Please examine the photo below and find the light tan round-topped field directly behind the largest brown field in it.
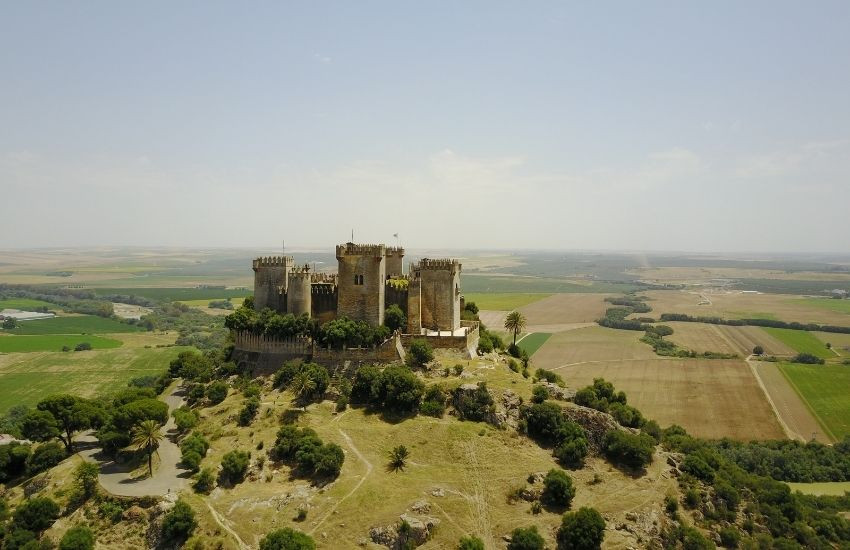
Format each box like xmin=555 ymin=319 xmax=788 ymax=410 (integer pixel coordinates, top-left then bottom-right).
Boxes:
xmin=533 ymin=326 xmax=657 ymax=369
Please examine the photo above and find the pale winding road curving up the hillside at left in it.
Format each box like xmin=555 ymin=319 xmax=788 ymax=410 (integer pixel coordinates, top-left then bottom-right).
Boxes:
xmin=76 ymin=384 xmax=191 ymax=497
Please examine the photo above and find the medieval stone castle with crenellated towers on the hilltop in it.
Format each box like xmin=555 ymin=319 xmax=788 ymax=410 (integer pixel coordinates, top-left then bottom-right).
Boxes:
xmin=253 ymin=242 xmax=470 ymax=337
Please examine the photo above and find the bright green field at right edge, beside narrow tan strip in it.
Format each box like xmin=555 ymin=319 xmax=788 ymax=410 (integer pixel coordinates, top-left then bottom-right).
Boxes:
xmin=779 ymin=363 xmax=850 ymax=440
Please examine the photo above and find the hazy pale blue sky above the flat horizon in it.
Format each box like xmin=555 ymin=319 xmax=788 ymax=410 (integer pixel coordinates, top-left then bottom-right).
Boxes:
xmin=0 ymin=0 xmax=850 ymax=252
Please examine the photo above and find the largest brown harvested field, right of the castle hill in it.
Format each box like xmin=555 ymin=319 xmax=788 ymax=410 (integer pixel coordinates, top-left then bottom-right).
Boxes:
xmin=539 ymin=360 xmax=785 ymax=440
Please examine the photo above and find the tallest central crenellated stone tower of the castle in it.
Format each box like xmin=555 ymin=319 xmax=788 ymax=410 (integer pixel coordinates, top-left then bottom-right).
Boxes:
xmin=336 ymin=243 xmax=387 ymax=326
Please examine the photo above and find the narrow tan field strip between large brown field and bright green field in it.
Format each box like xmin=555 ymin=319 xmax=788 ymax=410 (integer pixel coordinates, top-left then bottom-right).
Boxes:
xmin=750 ymin=361 xmax=832 ymax=443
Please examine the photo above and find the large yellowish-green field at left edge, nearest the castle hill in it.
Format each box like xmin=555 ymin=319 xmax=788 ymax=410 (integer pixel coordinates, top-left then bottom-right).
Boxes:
xmin=0 ymin=344 xmax=188 ymax=415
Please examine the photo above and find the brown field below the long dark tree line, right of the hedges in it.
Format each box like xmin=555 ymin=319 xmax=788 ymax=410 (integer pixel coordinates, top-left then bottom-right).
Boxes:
xmin=665 ymin=322 xmax=794 ymax=357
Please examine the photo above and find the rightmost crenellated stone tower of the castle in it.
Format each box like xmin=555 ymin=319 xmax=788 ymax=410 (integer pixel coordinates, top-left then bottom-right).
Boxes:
xmin=416 ymin=258 xmax=461 ymax=331
